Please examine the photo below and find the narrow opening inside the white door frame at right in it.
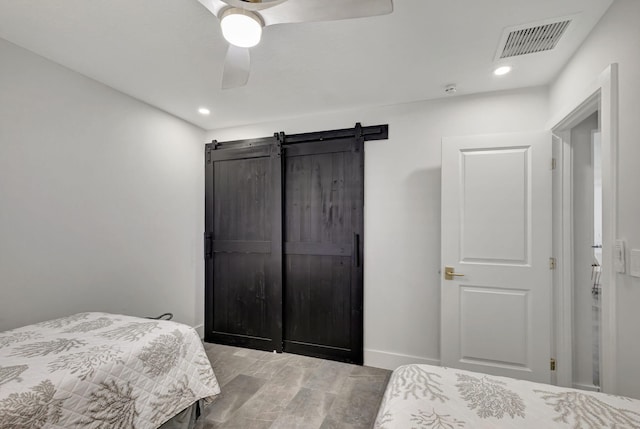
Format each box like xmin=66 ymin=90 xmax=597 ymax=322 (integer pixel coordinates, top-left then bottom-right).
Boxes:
xmin=556 ymin=110 xmax=603 ymax=391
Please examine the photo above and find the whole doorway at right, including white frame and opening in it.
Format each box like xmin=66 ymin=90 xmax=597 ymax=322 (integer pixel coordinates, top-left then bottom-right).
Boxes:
xmin=550 ymin=64 xmax=618 ymax=393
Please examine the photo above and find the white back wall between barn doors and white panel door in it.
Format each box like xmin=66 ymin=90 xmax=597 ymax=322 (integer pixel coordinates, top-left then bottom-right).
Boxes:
xmin=208 ymin=88 xmax=548 ymax=368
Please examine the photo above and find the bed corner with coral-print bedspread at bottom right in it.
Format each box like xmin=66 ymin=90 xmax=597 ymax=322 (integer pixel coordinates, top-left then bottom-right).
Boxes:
xmin=374 ymin=365 xmax=640 ymax=429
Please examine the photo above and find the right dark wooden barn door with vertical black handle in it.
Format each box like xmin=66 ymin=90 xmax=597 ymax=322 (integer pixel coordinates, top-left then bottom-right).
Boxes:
xmin=283 ymin=138 xmax=364 ymax=364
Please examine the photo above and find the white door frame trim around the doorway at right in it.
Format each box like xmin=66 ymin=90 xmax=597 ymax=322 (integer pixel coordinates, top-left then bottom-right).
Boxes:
xmin=548 ymin=64 xmax=618 ymax=393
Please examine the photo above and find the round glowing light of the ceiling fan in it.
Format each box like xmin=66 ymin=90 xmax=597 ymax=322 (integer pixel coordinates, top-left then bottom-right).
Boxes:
xmin=220 ymin=7 xmax=264 ymax=48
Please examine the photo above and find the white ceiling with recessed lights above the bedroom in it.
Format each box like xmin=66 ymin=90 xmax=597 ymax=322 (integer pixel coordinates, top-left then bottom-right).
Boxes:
xmin=0 ymin=0 xmax=612 ymax=129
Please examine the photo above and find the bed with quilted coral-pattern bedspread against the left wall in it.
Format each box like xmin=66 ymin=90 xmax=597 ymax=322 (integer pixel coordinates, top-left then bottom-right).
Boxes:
xmin=0 ymin=313 xmax=220 ymax=429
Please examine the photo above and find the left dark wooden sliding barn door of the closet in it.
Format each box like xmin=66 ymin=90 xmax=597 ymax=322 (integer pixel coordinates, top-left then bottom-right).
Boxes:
xmin=205 ymin=139 xmax=282 ymax=351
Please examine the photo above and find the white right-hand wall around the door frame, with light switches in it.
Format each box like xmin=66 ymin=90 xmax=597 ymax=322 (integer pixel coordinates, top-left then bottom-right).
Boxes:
xmin=550 ymin=0 xmax=640 ymax=398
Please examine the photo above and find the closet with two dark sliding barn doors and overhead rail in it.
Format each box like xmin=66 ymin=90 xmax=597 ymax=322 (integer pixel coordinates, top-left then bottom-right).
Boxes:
xmin=205 ymin=124 xmax=388 ymax=364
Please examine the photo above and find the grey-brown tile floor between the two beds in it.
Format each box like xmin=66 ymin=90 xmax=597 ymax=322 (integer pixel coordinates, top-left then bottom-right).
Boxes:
xmin=196 ymin=343 xmax=391 ymax=429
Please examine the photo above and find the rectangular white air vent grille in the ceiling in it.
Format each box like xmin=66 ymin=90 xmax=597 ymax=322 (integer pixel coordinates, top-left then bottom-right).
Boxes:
xmin=496 ymin=19 xmax=571 ymax=60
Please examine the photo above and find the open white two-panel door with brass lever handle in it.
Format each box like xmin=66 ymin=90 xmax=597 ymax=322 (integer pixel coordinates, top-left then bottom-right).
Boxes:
xmin=441 ymin=132 xmax=552 ymax=383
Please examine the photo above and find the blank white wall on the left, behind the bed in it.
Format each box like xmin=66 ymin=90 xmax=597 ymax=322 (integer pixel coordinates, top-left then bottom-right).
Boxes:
xmin=0 ymin=39 xmax=204 ymax=331
